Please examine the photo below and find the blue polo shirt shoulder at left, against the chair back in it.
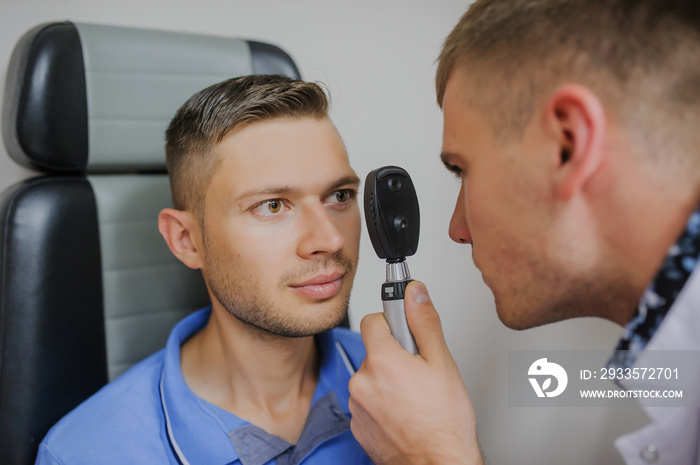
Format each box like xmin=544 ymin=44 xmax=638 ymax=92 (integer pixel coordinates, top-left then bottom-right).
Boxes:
xmin=37 ymin=351 xmax=170 ymax=464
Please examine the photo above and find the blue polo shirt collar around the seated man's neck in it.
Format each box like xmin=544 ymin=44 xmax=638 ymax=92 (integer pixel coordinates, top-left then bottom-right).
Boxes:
xmin=160 ymin=307 xmax=354 ymax=465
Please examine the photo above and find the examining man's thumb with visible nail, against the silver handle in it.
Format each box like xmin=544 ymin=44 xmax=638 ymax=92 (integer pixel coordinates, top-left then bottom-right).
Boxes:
xmin=405 ymin=281 xmax=449 ymax=360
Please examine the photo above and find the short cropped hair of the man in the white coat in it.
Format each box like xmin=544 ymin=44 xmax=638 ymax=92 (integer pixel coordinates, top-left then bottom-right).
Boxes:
xmin=436 ymin=0 xmax=700 ymax=158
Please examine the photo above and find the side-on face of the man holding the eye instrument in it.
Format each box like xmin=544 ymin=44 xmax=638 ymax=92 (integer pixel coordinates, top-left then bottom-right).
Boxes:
xmin=442 ymin=67 xmax=590 ymax=329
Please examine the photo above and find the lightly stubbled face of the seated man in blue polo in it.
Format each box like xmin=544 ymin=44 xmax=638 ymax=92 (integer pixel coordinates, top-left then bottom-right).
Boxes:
xmin=202 ymin=118 xmax=360 ymax=337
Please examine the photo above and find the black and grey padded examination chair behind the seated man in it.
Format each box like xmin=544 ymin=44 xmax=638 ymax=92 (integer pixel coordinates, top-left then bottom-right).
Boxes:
xmin=0 ymin=22 xmax=299 ymax=465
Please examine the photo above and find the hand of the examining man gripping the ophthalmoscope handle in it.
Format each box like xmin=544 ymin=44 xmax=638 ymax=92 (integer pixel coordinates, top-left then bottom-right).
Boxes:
xmin=349 ymin=281 xmax=483 ymax=465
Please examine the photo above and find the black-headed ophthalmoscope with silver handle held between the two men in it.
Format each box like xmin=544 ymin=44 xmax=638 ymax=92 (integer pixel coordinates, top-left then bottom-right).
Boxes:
xmin=364 ymin=166 xmax=420 ymax=354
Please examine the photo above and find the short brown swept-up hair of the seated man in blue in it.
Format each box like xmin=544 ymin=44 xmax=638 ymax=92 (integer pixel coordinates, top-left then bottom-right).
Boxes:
xmin=165 ymin=75 xmax=328 ymax=215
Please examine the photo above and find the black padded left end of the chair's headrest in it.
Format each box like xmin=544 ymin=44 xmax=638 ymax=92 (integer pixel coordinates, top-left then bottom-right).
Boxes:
xmin=3 ymin=22 xmax=88 ymax=172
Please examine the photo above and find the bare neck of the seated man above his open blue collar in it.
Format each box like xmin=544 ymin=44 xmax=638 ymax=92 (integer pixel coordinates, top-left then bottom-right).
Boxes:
xmin=181 ymin=306 xmax=318 ymax=444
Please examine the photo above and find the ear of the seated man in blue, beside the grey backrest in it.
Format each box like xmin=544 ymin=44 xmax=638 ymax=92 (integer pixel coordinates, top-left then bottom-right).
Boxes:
xmin=158 ymin=208 xmax=202 ymax=270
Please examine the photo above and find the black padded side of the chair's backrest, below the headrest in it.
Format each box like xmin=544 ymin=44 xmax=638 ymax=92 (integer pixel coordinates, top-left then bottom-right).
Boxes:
xmin=0 ymin=177 xmax=107 ymax=465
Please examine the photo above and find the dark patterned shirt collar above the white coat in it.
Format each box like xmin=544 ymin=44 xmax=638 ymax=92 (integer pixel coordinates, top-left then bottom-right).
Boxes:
xmin=608 ymin=208 xmax=700 ymax=368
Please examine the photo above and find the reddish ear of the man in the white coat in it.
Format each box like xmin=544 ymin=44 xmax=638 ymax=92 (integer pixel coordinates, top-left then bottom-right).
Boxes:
xmin=545 ymin=84 xmax=606 ymax=200
